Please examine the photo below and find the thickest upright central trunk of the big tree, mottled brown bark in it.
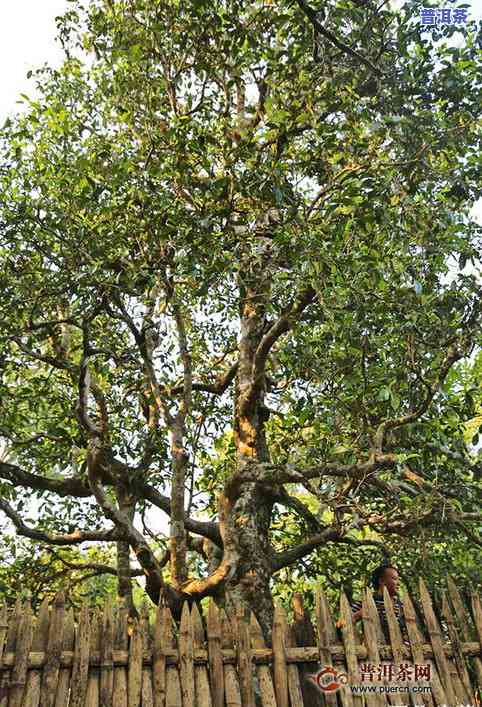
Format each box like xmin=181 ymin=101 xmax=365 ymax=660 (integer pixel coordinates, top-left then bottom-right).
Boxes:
xmin=226 ymin=253 xmax=274 ymax=642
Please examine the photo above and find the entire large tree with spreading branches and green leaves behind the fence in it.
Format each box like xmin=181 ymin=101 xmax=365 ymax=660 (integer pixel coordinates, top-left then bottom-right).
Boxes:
xmin=0 ymin=0 xmax=482 ymax=633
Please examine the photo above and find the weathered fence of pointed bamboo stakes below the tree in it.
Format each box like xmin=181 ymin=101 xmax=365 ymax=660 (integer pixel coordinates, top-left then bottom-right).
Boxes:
xmin=0 ymin=580 xmax=482 ymax=707
